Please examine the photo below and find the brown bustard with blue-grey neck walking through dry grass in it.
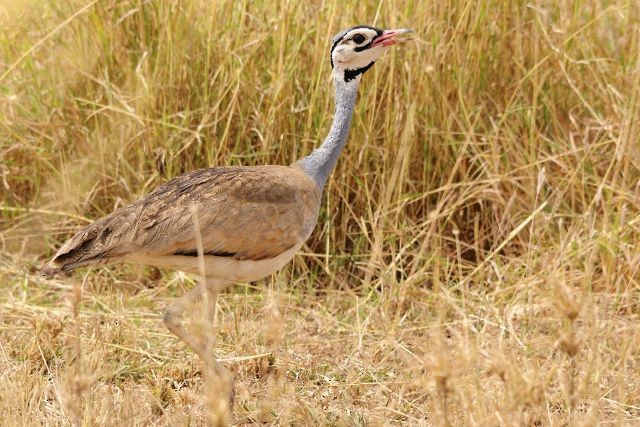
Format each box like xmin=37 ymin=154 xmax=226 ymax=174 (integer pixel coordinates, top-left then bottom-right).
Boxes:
xmin=39 ymin=25 xmax=412 ymax=412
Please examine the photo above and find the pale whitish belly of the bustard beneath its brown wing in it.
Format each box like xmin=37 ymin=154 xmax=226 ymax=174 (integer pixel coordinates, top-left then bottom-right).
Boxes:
xmin=131 ymin=242 xmax=304 ymax=284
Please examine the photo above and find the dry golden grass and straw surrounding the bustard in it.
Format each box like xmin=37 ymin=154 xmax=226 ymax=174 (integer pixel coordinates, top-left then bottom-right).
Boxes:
xmin=0 ymin=0 xmax=640 ymax=426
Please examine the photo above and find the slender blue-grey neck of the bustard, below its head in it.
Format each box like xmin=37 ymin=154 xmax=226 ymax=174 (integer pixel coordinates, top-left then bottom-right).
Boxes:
xmin=298 ymin=72 xmax=360 ymax=190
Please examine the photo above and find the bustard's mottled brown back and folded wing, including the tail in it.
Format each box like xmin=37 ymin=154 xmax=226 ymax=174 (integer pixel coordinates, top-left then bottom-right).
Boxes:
xmin=41 ymin=166 xmax=320 ymax=274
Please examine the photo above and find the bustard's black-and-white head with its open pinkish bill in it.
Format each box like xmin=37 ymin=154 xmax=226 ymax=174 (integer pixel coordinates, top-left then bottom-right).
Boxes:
xmin=331 ymin=25 xmax=412 ymax=83
